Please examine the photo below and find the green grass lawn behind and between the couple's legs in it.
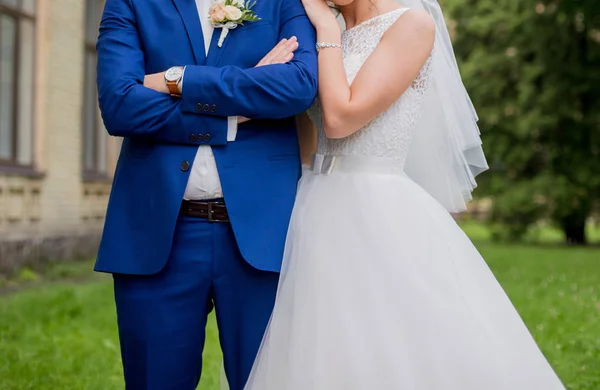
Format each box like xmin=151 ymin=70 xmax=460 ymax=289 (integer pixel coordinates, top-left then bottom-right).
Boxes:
xmin=0 ymin=233 xmax=600 ymax=390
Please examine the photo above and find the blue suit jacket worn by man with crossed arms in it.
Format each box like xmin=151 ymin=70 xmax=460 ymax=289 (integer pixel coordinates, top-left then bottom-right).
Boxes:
xmin=96 ymin=0 xmax=317 ymax=275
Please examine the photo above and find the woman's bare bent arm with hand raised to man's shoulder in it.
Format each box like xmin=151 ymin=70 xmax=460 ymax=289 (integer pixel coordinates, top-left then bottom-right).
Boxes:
xmin=304 ymin=0 xmax=435 ymax=138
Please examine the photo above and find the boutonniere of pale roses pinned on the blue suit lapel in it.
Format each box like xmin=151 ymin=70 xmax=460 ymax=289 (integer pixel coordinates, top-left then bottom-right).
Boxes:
xmin=208 ymin=0 xmax=260 ymax=47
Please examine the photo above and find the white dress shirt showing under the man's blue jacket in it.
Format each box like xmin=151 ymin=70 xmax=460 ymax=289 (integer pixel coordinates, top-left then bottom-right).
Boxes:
xmin=181 ymin=0 xmax=237 ymax=200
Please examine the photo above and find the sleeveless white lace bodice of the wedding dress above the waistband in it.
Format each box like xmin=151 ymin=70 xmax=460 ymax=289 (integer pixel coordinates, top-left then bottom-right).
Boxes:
xmin=308 ymin=8 xmax=431 ymax=166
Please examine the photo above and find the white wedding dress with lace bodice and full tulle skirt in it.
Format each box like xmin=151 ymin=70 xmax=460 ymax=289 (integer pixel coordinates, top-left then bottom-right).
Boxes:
xmin=246 ymin=9 xmax=564 ymax=390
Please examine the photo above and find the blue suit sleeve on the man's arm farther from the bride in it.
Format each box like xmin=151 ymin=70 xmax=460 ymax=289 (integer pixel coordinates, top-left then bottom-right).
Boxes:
xmin=97 ymin=0 xmax=227 ymax=145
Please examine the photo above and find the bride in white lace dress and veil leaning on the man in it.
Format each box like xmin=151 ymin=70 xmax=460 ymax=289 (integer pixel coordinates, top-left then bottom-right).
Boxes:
xmin=246 ymin=0 xmax=564 ymax=390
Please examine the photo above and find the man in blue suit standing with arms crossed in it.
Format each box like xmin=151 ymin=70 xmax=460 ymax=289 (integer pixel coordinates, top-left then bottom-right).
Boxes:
xmin=95 ymin=0 xmax=317 ymax=390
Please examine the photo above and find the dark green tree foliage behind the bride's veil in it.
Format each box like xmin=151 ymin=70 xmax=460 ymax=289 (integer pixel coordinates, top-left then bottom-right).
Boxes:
xmin=440 ymin=0 xmax=600 ymax=243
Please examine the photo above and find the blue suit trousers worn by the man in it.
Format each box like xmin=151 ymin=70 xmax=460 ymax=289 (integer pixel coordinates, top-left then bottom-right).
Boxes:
xmin=114 ymin=217 xmax=279 ymax=390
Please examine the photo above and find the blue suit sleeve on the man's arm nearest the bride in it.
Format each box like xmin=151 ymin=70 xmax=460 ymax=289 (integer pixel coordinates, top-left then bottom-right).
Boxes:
xmin=182 ymin=0 xmax=317 ymax=119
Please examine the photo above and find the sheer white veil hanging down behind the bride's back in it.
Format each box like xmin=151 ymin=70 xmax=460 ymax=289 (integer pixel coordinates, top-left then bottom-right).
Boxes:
xmin=398 ymin=0 xmax=488 ymax=212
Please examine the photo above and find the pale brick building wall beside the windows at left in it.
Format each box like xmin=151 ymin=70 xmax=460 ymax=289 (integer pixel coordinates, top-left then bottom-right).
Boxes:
xmin=0 ymin=0 xmax=119 ymax=273
